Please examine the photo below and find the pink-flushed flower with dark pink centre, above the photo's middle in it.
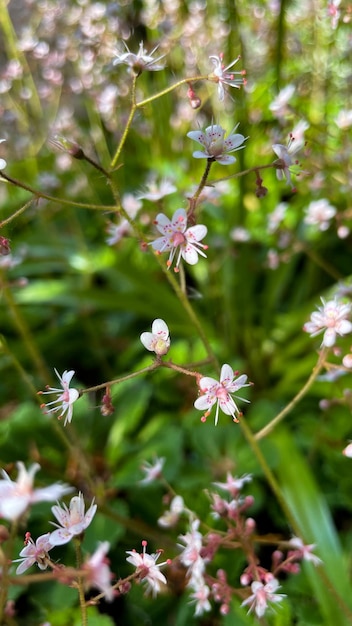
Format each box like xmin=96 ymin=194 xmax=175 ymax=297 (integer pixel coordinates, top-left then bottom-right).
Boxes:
xmin=150 ymin=209 xmax=208 ymax=272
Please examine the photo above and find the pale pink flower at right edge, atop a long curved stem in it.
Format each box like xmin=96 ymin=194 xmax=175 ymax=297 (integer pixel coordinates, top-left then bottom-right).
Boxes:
xmin=303 ymin=297 xmax=352 ymax=348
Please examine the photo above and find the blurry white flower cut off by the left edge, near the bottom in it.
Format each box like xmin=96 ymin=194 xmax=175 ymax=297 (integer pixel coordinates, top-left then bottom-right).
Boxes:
xmin=0 ymin=461 xmax=72 ymax=521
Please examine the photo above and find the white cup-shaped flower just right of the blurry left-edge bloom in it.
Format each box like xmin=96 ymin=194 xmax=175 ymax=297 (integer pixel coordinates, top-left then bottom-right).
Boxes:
xmin=50 ymin=493 xmax=97 ymax=546
